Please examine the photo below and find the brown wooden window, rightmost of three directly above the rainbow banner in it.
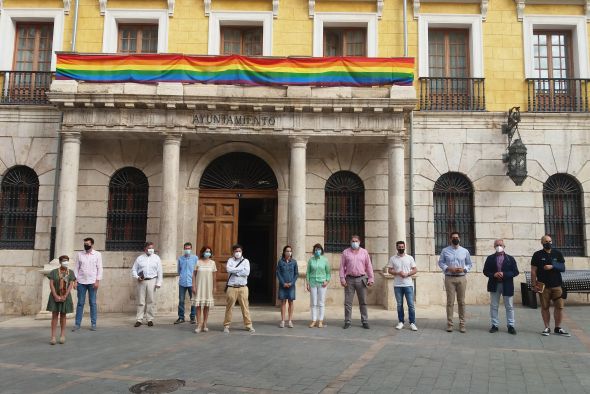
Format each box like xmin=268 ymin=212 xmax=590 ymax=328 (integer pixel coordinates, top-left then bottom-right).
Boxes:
xmin=324 ymin=27 xmax=367 ymax=56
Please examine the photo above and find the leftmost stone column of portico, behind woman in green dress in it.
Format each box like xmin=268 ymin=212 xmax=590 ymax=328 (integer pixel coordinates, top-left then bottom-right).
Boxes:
xmin=55 ymin=133 xmax=81 ymax=261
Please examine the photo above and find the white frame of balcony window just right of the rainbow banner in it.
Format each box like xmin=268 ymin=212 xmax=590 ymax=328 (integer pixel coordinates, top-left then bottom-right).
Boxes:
xmin=418 ymin=14 xmax=484 ymax=78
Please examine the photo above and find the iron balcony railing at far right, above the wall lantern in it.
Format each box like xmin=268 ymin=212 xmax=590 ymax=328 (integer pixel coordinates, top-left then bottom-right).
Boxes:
xmin=526 ymin=78 xmax=590 ymax=112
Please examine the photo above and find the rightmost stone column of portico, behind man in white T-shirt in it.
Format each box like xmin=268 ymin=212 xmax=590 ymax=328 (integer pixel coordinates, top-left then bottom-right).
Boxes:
xmin=387 ymin=136 xmax=408 ymax=256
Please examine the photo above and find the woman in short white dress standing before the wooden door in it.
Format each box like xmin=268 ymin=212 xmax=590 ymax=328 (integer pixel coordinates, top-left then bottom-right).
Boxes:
xmin=193 ymin=246 xmax=217 ymax=332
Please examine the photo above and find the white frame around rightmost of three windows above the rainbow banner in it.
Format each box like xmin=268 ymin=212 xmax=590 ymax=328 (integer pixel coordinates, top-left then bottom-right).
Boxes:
xmin=313 ymin=12 xmax=378 ymax=57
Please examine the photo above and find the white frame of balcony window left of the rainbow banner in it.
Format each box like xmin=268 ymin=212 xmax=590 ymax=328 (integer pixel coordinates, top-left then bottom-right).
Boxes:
xmin=0 ymin=8 xmax=64 ymax=71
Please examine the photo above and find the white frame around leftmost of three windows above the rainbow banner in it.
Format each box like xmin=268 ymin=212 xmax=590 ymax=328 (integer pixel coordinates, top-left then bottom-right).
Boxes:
xmin=102 ymin=8 xmax=168 ymax=53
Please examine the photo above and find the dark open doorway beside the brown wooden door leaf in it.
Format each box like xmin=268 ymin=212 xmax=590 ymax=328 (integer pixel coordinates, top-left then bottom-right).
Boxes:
xmin=238 ymin=198 xmax=276 ymax=304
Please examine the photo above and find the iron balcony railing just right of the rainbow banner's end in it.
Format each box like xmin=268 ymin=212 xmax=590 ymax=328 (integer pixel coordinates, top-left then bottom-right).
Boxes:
xmin=419 ymin=78 xmax=486 ymax=111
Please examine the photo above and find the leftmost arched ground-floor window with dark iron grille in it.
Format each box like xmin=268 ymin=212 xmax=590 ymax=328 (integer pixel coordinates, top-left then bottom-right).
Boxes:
xmin=0 ymin=166 xmax=39 ymax=249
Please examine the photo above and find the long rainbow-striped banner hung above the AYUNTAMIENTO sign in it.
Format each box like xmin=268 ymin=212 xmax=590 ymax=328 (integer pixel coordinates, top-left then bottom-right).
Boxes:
xmin=56 ymin=53 xmax=414 ymax=86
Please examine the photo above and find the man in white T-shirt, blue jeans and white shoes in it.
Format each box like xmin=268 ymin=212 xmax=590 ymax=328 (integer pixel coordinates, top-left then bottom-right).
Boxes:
xmin=387 ymin=241 xmax=418 ymax=331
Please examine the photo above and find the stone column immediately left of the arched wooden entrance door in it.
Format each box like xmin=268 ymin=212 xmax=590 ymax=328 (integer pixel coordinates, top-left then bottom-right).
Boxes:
xmin=158 ymin=134 xmax=182 ymax=273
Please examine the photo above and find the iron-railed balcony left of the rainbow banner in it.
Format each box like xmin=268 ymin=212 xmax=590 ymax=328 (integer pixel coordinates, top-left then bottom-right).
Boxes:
xmin=0 ymin=71 xmax=53 ymax=105
